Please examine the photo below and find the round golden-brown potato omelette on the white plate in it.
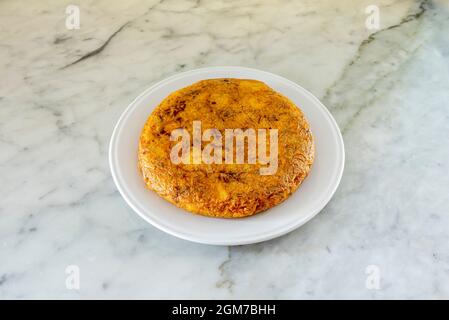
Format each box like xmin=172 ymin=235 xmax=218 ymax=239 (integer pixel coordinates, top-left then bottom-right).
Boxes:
xmin=138 ymin=78 xmax=314 ymax=218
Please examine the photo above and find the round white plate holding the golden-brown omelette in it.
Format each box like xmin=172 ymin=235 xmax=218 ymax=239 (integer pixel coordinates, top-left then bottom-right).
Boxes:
xmin=109 ymin=67 xmax=345 ymax=245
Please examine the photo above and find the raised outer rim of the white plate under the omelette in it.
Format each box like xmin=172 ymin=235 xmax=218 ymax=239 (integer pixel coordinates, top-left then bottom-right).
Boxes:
xmin=108 ymin=66 xmax=346 ymax=246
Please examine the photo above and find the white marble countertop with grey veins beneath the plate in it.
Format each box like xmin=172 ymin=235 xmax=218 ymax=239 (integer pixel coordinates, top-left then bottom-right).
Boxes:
xmin=0 ymin=0 xmax=449 ymax=299
